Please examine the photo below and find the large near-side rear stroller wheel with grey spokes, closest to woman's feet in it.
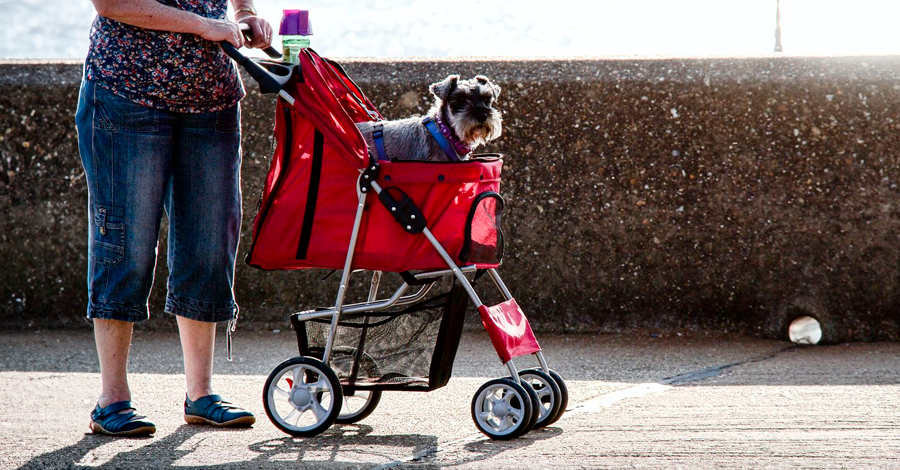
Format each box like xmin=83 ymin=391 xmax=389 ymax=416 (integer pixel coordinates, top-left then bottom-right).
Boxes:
xmin=263 ymin=357 xmax=343 ymax=437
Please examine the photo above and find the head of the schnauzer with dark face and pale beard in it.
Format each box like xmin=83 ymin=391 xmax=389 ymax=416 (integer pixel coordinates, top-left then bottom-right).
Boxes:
xmin=429 ymin=75 xmax=503 ymax=148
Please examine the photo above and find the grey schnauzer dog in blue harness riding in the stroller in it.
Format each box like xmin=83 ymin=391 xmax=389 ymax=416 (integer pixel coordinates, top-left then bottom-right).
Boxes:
xmin=356 ymin=75 xmax=503 ymax=161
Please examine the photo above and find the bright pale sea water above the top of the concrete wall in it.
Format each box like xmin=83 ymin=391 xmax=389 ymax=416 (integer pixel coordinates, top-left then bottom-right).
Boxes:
xmin=0 ymin=0 xmax=900 ymax=59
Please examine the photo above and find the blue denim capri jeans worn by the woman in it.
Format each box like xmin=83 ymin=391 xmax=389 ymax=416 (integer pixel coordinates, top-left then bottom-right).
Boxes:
xmin=75 ymin=80 xmax=241 ymax=322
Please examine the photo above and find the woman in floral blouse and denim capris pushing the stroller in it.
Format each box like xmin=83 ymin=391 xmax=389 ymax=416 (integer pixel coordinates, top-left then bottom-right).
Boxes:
xmin=75 ymin=0 xmax=272 ymax=436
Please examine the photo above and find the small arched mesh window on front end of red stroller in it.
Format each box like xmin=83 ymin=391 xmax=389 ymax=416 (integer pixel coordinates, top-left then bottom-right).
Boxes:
xmin=459 ymin=191 xmax=503 ymax=264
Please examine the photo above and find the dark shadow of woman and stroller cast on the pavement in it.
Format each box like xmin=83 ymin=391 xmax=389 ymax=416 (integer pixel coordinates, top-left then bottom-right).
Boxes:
xmin=20 ymin=425 xmax=562 ymax=470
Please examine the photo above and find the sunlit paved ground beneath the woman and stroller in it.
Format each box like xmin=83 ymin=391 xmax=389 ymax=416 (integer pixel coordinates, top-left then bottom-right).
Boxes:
xmin=0 ymin=331 xmax=900 ymax=469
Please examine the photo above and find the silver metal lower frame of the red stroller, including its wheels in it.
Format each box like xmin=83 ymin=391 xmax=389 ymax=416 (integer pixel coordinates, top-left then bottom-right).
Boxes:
xmin=263 ymin=169 xmax=568 ymax=440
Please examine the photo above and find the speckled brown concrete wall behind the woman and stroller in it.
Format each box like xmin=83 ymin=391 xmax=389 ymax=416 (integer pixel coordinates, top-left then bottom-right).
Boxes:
xmin=0 ymin=57 xmax=900 ymax=341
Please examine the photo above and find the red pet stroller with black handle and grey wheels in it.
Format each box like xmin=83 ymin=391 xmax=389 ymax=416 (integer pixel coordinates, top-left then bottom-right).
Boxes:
xmin=226 ymin=41 xmax=568 ymax=439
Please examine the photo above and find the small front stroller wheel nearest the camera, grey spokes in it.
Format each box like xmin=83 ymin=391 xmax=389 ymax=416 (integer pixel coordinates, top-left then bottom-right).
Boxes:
xmin=472 ymin=378 xmax=534 ymax=440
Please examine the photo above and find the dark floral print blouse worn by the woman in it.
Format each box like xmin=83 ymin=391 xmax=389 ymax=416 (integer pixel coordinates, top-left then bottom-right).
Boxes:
xmin=85 ymin=0 xmax=244 ymax=113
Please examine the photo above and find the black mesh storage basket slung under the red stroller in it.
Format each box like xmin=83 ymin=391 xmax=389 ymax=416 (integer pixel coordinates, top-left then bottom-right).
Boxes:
xmin=305 ymin=284 xmax=469 ymax=390
